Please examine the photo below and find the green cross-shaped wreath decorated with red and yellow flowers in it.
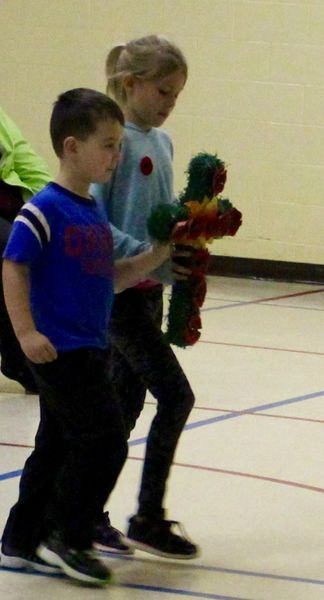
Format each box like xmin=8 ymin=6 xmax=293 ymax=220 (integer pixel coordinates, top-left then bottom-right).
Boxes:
xmin=148 ymin=152 xmax=242 ymax=348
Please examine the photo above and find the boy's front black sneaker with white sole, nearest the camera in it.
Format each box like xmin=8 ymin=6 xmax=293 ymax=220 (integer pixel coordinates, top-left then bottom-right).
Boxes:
xmin=37 ymin=535 xmax=112 ymax=585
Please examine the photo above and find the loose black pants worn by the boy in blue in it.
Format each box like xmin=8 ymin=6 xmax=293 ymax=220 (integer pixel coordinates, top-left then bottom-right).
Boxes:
xmin=2 ymin=348 xmax=127 ymax=552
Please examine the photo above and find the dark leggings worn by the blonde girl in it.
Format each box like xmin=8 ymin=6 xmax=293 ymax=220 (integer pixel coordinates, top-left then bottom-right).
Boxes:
xmin=109 ymin=285 xmax=194 ymax=518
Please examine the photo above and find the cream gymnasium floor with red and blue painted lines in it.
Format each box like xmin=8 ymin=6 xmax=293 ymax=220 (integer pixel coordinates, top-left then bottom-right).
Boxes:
xmin=0 ymin=278 xmax=324 ymax=600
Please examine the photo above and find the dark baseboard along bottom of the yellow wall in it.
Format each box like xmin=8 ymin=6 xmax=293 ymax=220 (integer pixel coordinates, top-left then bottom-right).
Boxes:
xmin=209 ymin=256 xmax=324 ymax=284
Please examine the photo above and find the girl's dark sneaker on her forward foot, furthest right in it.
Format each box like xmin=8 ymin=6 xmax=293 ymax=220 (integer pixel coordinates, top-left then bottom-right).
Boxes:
xmin=125 ymin=516 xmax=199 ymax=559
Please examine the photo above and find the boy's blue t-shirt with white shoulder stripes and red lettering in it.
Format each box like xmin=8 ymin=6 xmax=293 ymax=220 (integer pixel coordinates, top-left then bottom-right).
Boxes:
xmin=3 ymin=183 xmax=113 ymax=351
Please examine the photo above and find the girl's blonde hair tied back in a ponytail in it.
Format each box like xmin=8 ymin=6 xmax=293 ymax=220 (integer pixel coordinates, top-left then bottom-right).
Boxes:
xmin=106 ymin=35 xmax=188 ymax=104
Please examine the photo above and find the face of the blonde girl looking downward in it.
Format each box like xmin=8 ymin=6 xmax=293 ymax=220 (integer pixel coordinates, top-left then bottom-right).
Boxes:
xmin=123 ymin=70 xmax=186 ymax=129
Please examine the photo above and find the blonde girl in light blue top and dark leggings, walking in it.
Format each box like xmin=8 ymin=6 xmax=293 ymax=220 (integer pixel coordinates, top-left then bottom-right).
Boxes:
xmin=92 ymin=35 xmax=198 ymax=559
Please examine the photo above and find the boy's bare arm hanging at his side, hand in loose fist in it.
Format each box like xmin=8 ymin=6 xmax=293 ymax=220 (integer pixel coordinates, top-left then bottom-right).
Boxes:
xmin=2 ymin=259 xmax=57 ymax=363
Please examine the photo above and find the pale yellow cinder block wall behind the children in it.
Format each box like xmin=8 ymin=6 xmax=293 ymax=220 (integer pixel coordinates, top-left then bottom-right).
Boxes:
xmin=0 ymin=0 xmax=324 ymax=264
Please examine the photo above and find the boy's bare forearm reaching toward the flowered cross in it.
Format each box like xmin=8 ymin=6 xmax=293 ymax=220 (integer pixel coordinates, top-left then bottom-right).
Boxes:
xmin=114 ymin=243 xmax=171 ymax=293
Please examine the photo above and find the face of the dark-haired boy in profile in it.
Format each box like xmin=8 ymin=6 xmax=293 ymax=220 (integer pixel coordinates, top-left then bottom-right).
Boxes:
xmin=77 ymin=118 xmax=124 ymax=183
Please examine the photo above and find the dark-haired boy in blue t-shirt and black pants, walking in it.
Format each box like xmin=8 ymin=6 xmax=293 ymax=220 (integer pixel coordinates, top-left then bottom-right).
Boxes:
xmin=1 ymin=88 xmax=170 ymax=585
